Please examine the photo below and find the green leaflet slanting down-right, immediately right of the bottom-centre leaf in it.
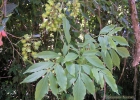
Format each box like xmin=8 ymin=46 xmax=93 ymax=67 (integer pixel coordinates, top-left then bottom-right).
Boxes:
xmin=81 ymin=73 xmax=95 ymax=95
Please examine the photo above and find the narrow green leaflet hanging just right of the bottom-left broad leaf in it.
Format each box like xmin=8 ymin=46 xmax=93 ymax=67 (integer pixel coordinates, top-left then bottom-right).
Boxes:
xmin=49 ymin=73 xmax=58 ymax=96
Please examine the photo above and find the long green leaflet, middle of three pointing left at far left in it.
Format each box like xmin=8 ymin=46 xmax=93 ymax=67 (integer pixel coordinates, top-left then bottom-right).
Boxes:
xmin=24 ymin=61 xmax=54 ymax=74
